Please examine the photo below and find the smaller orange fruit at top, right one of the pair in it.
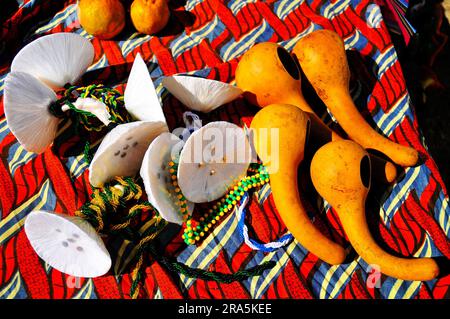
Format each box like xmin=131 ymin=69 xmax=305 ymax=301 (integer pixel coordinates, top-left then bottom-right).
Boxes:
xmin=130 ymin=0 xmax=170 ymax=34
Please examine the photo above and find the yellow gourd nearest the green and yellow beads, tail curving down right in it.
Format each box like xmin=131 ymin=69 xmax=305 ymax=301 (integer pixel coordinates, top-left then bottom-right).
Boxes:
xmin=251 ymin=104 xmax=346 ymax=265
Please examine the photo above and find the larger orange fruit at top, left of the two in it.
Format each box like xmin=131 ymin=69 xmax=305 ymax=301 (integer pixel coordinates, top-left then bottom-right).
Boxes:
xmin=78 ymin=0 xmax=125 ymax=39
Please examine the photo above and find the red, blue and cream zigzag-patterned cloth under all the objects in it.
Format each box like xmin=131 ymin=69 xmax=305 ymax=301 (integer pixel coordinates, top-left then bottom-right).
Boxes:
xmin=0 ymin=0 xmax=450 ymax=298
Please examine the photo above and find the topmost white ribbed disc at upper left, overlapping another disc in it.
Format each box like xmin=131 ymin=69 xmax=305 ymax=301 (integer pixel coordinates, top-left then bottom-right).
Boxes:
xmin=11 ymin=32 xmax=94 ymax=89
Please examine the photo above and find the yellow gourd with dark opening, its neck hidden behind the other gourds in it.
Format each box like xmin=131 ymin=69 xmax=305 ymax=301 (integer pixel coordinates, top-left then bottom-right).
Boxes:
xmin=236 ymin=42 xmax=397 ymax=183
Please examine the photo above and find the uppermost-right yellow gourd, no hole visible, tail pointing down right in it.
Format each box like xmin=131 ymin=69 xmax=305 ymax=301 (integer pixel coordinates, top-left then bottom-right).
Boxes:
xmin=293 ymin=30 xmax=419 ymax=166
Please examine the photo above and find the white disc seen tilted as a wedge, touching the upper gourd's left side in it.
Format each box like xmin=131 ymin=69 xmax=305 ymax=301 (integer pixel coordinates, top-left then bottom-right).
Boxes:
xmin=162 ymin=75 xmax=243 ymax=113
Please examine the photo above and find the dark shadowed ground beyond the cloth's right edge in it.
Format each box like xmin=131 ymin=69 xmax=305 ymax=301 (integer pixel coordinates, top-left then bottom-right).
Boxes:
xmin=398 ymin=0 xmax=450 ymax=188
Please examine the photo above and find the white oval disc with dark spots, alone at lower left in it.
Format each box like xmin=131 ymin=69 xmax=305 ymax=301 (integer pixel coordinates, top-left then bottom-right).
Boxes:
xmin=24 ymin=211 xmax=111 ymax=278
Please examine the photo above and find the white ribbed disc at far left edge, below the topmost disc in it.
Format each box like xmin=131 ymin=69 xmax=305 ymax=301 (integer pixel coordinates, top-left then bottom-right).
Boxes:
xmin=4 ymin=72 xmax=60 ymax=153
